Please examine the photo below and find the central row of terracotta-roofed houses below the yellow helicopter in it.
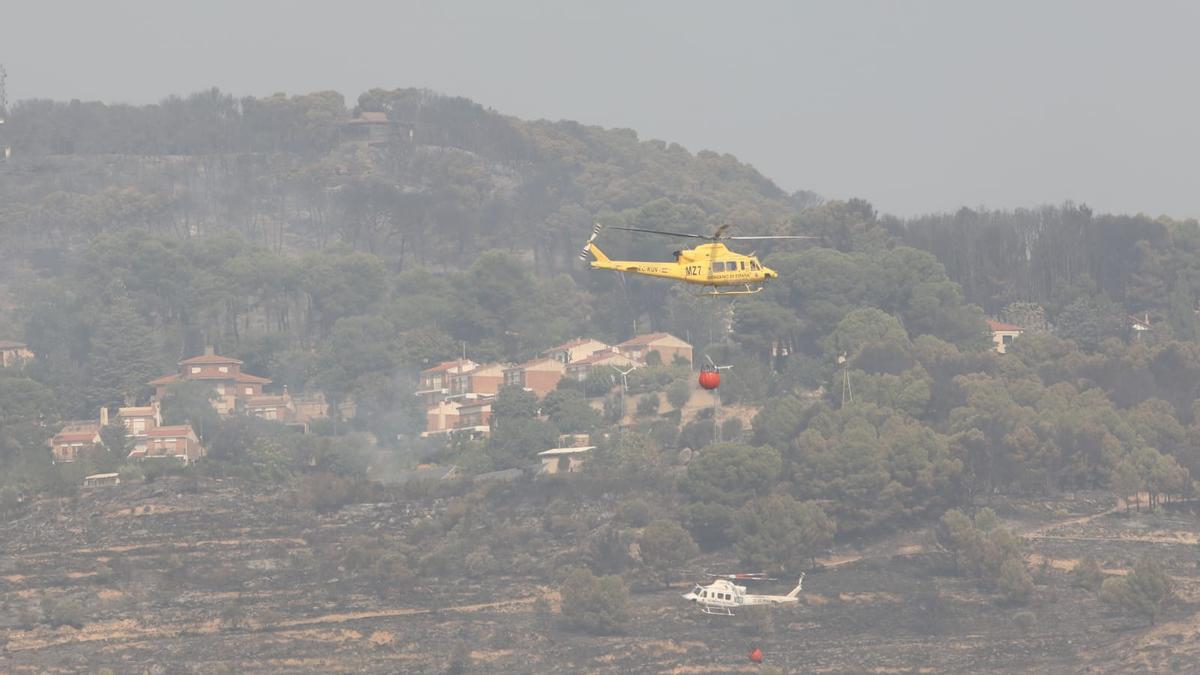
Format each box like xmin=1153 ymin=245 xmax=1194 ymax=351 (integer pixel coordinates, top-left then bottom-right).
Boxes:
xmin=416 ymin=333 xmax=692 ymax=437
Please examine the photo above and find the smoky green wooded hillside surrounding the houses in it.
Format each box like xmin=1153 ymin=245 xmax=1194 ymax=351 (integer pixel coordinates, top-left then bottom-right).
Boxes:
xmin=0 ymin=89 xmax=1200 ymax=544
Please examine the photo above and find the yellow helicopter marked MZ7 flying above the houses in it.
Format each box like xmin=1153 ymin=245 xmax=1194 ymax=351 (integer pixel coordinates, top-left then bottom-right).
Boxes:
xmin=580 ymin=223 xmax=815 ymax=295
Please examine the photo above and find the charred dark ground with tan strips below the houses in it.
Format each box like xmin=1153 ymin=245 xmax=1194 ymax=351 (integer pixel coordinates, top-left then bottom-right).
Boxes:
xmin=0 ymin=479 xmax=1200 ymax=673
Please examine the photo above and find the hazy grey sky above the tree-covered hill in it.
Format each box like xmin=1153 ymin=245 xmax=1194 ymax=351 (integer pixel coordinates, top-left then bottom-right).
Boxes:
xmin=9 ymin=0 xmax=1200 ymax=216
